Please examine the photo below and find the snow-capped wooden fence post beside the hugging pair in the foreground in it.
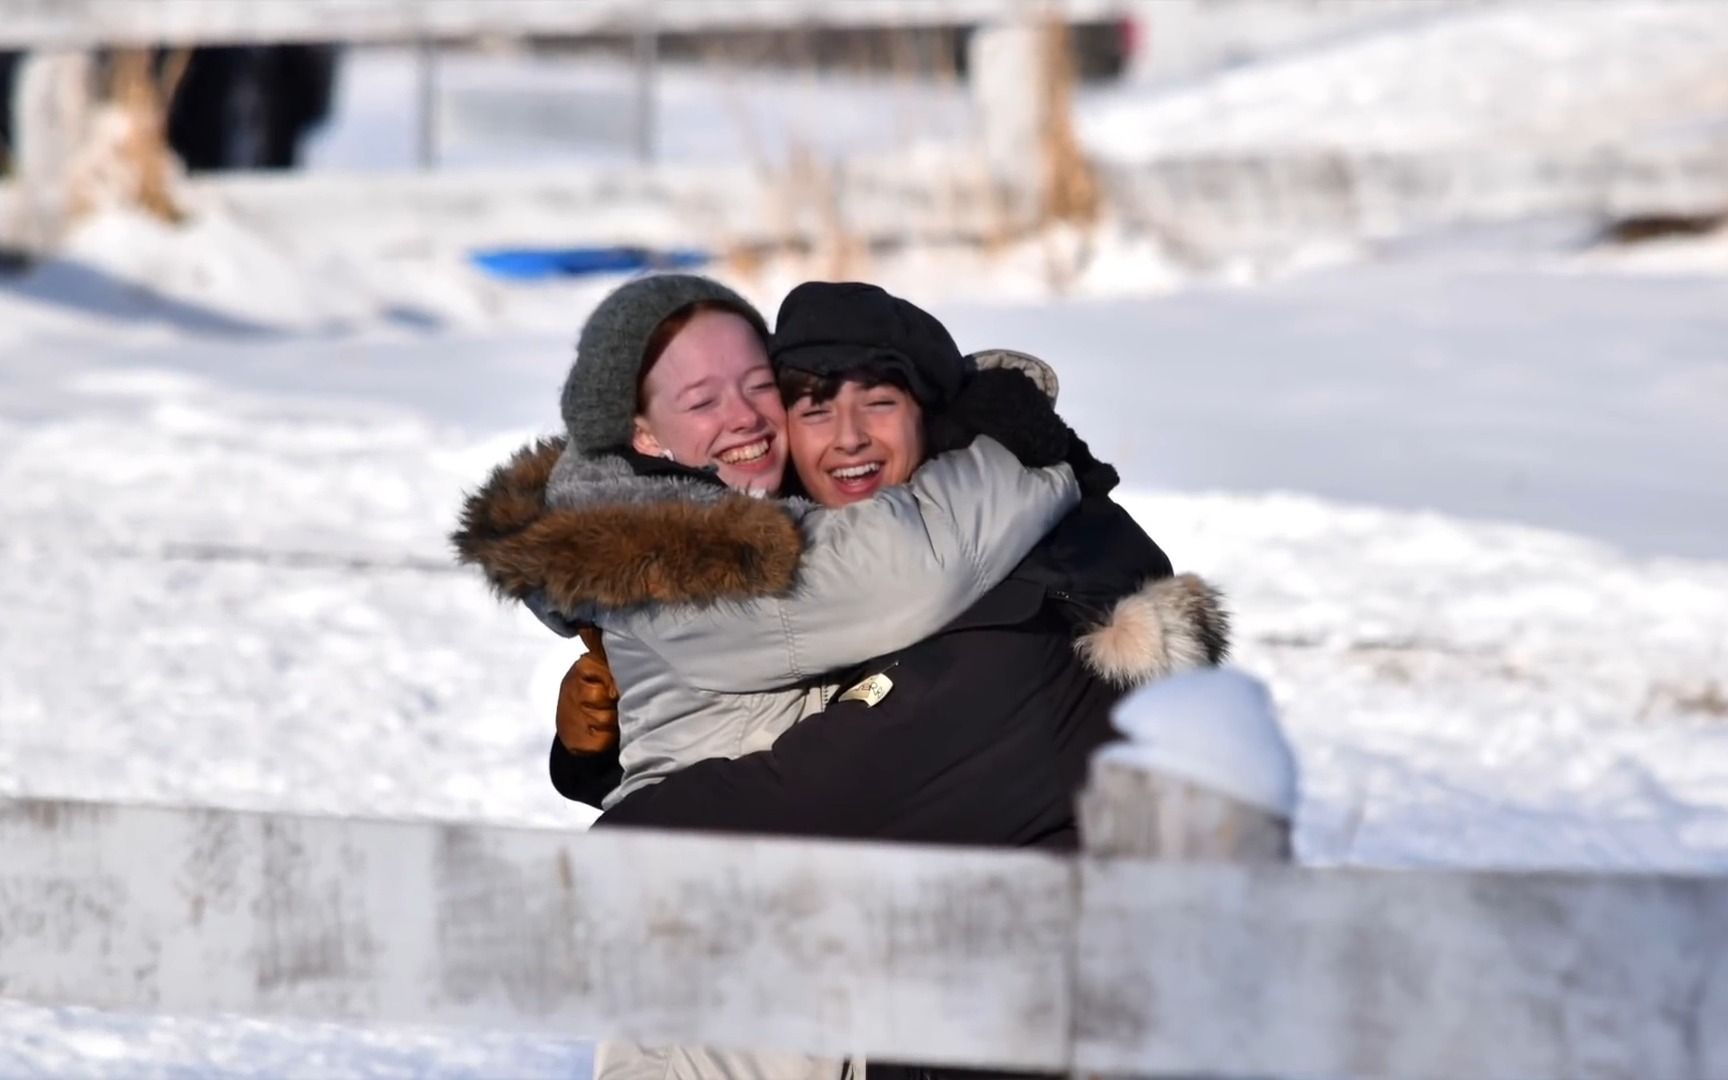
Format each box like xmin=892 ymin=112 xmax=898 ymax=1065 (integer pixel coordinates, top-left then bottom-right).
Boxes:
xmin=1075 ymin=669 xmax=1296 ymax=1080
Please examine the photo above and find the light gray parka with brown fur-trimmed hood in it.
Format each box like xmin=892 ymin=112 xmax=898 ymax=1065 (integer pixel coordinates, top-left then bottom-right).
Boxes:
xmin=454 ymin=437 xmax=1078 ymax=807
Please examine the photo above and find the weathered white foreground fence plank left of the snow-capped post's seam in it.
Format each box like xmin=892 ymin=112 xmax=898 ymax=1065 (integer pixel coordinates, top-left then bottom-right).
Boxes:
xmin=0 ymin=800 xmax=1075 ymax=1068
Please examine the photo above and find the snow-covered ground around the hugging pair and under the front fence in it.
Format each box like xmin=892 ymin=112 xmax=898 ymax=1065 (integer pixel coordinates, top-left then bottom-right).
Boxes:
xmin=0 ymin=5 xmax=1728 ymax=1077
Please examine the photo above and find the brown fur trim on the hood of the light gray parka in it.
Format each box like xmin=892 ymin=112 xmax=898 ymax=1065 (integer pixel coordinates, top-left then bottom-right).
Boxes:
xmin=451 ymin=437 xmax=804 ymax=613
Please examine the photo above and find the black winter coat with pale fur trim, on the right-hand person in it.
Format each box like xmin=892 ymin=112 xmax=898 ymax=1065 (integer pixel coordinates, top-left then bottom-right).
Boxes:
xmin=551 ymin=498 xmax=1225 ymax=848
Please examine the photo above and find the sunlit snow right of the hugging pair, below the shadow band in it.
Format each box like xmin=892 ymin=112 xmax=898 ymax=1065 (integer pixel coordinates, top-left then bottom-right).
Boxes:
xmin=1123 ymin=494 xmax=1728 ymax=873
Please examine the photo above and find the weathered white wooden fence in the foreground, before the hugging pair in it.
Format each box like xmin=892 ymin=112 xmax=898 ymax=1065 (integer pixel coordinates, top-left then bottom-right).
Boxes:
xmin=0 ymin=670 xmax=1728 ymax=1080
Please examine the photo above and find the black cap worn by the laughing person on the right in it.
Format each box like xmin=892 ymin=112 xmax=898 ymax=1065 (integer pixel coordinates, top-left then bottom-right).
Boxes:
xmin=769 ymin=282 xmax=973 ymax=411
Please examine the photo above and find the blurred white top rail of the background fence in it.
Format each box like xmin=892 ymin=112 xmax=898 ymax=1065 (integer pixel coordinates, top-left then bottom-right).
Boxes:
xmin=0 ymin=0 xmax=1125 ymax=48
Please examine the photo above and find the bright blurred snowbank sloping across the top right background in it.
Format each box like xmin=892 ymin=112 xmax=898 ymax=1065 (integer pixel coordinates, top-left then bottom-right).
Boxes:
xmin=1080 ymin=0 xmax=1728 ymax=159
